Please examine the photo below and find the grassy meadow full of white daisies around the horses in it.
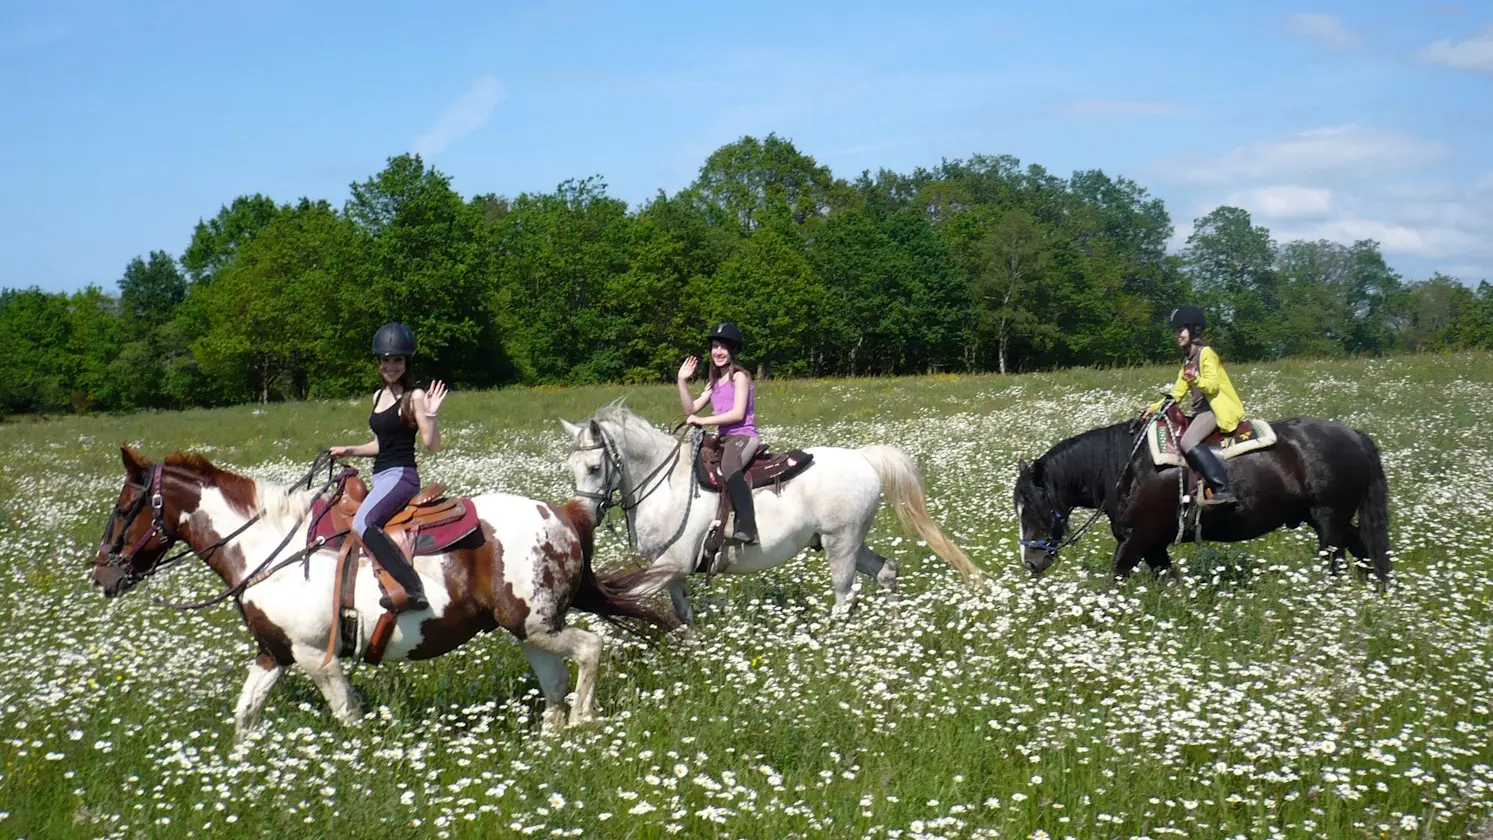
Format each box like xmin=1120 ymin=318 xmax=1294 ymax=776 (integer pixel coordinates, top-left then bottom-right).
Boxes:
xmin=0 ymin=354 xmax=1493 ymax=840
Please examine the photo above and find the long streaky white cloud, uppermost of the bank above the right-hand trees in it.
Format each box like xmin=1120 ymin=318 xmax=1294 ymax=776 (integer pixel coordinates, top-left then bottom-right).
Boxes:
xmin=1157 ymin=125 xmax=1448 ymax=185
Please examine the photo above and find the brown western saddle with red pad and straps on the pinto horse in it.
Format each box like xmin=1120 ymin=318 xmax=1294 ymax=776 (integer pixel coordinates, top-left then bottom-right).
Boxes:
xmin=306 ymin=467 xmax=484 ymax=665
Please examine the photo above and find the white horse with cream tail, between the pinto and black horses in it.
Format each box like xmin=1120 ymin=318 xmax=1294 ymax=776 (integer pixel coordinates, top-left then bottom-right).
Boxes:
xmin=560 ymin=403 xmax=981 ymax=627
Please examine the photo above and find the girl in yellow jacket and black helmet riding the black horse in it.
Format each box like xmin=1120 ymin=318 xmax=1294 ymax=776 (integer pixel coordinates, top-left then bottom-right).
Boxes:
xmin=1141 ymin=306 xmax=1244 ymax=506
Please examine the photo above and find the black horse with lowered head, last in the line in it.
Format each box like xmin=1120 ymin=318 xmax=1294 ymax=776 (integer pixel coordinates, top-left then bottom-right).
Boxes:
xmin=1012 ymin=418 xmax=1390 ymax=586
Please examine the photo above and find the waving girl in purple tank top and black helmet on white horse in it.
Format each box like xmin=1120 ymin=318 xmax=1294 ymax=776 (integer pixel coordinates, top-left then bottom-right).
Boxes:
xmin=679 ymin=324 xmax=760 ymax=545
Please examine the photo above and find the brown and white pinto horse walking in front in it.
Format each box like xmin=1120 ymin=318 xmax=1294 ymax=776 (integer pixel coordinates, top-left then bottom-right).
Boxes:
xmin=93 ymin=448 xmax=672 ymax=737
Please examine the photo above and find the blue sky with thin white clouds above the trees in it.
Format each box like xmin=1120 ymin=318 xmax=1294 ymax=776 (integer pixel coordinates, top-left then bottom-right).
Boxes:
xmin=0 ymin=0 xmax=1493 ymax=291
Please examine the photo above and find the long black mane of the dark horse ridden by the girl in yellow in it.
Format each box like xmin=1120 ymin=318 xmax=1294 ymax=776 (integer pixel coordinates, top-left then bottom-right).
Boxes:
xmin=1014 ymin=421 xmax=1135 ymax=510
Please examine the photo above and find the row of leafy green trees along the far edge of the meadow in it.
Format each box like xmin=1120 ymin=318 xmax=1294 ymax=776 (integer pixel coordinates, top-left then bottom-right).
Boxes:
xmin=0 ymin=136 xmax=1493 ymax=413
